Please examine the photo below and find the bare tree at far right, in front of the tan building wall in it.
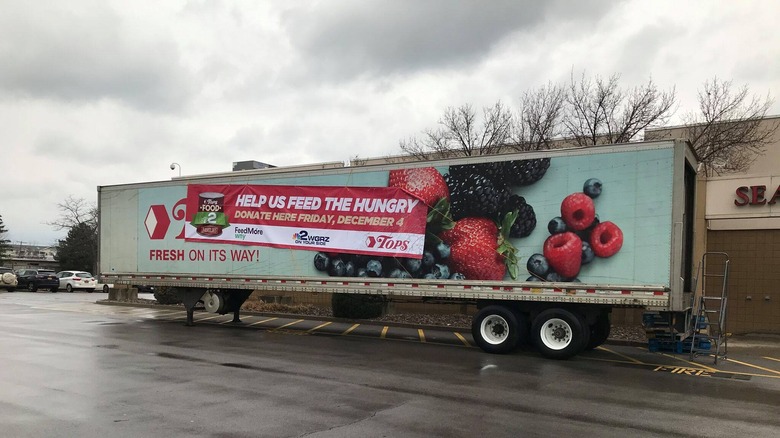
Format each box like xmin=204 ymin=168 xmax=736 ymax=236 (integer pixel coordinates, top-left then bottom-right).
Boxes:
xmin=684 ymin=77 xmax=780 ymax=176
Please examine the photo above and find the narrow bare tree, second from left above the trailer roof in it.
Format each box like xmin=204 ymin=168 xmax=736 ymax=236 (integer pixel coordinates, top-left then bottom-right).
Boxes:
xmin=511 ymin=83 xmax=566 ymax=151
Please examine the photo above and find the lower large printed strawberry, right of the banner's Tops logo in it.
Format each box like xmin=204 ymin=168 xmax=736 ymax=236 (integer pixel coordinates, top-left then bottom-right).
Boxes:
xmin=440 ymin=214 xmax=517 ymax=280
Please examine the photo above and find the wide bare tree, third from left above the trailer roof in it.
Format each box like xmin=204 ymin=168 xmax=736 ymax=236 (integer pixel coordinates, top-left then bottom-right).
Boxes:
xmin=563 ymin=73 xmax=676 ymax=146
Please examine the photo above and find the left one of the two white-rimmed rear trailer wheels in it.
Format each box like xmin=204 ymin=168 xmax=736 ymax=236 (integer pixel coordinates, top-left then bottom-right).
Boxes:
xmin=471 ymin=305 xmax=527 ymax=354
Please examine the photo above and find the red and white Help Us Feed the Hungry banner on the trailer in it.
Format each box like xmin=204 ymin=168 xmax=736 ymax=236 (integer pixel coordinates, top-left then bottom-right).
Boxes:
xmin=184 ymin=185 xmax=428 ymax=258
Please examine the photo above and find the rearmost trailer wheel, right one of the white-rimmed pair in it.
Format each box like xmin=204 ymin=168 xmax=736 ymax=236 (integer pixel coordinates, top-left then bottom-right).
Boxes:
xmin=531 ymin=309 xmax=590 ymax=359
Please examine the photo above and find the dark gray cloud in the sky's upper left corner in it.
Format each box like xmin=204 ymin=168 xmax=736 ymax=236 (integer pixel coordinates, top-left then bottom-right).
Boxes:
xmin=0 ymin=2 xmax=190 ymax=111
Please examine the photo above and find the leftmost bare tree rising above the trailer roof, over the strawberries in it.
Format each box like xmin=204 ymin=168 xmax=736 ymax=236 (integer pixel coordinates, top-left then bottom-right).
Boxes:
xmin=399 ymin=101 xmax=512 ymax=160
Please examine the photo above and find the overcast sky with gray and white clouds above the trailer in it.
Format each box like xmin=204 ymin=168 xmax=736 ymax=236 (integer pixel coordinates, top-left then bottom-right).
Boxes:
xmin=0 ymin=0 xmax=780 ymax=245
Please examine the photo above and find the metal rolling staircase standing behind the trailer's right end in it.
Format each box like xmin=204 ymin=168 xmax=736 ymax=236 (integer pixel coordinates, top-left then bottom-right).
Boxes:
xmin=690 ymin=252 xmax=729 ymax=365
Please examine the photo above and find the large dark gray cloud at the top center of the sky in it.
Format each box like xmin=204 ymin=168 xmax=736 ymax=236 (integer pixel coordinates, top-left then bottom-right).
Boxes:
xmin=283 ymin=0 xmax=614 ymax=79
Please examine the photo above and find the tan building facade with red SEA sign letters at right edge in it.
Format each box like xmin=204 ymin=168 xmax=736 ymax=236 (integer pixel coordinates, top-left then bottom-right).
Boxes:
xmin=645 ymin=116 xmax=780 ymax=333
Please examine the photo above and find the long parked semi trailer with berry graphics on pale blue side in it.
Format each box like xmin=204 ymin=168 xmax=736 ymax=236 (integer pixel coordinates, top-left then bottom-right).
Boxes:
xmin=98 ymin=140 xmax=697 ymax=359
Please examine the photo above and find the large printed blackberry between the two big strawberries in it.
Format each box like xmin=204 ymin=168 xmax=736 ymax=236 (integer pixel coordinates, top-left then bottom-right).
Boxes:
xmin=444 ymin=173 xmax=509 ymax=220
